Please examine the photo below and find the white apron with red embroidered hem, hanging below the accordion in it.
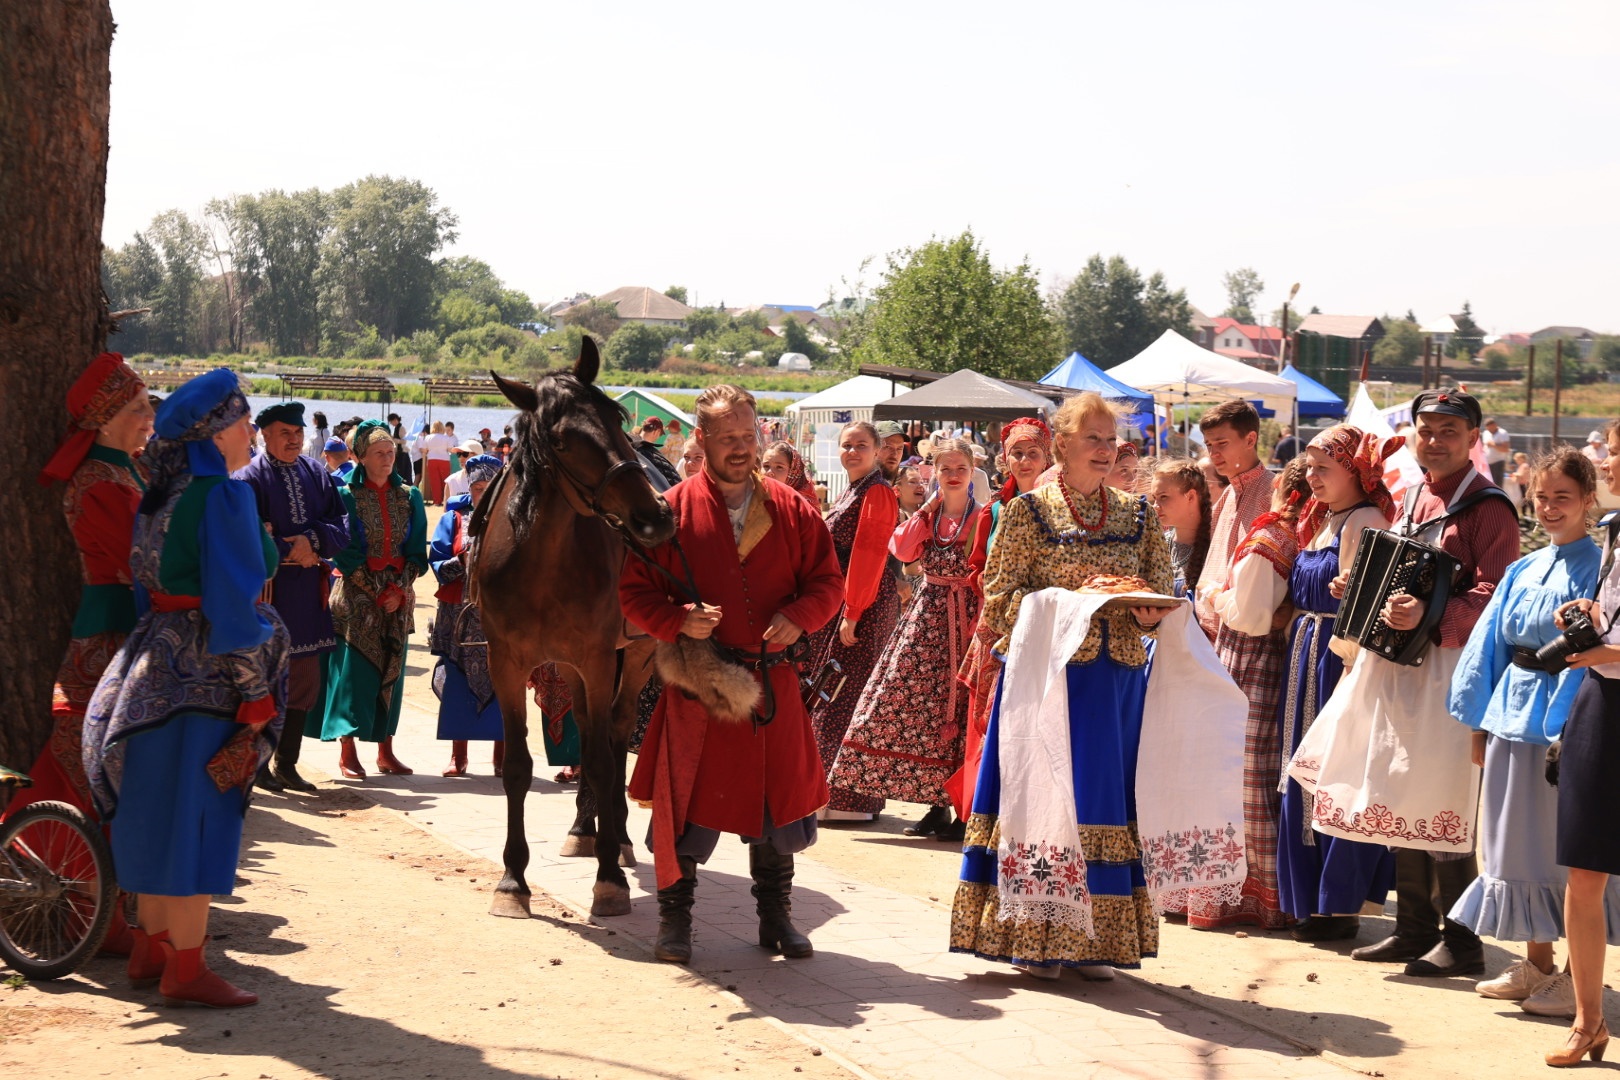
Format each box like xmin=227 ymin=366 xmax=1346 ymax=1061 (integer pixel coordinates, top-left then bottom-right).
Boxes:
xmin=1288 ymin=646 xmax=1479 ymax=855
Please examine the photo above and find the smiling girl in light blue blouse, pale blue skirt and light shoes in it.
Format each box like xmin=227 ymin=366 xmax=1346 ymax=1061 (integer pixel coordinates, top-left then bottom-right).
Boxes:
xmin=1450 ymin=447 xmax=1620 ymax=1036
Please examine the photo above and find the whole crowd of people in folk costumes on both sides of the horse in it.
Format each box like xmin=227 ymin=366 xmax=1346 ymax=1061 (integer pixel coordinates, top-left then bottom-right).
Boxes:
xmin=12 ymin=353 xmax=1620 ymax=1064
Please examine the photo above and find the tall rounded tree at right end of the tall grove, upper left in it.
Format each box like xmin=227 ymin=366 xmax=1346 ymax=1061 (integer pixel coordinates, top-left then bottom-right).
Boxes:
xmin=321 ymin=176 xmax=458 ymax=340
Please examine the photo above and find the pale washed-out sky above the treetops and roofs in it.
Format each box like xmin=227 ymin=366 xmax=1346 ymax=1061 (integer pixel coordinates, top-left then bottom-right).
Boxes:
xmin=105 ymin=0 xmax=1620 ymax=332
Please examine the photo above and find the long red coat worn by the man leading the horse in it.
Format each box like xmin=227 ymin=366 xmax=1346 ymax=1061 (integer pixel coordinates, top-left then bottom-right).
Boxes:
xmin=619 ymin=471 xmax=844 ymax=886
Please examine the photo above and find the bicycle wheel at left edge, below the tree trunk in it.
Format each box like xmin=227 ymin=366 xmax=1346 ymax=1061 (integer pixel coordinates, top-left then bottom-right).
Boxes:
xmin=0 ymin=801 xmax=118 ymax=980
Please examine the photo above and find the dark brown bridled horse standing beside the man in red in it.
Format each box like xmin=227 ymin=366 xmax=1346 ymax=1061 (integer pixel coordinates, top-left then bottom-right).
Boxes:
xmin=471 ymin=337 xmax=676 ymax=918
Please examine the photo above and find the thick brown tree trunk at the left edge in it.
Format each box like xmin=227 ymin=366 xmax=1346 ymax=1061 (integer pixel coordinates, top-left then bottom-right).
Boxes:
xmin=0 ymin=0 xmax=113 ymax=769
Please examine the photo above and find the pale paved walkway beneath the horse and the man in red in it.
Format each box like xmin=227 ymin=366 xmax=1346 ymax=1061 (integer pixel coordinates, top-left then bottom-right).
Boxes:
xmin=305 ymin=689 xmax=1354 ymax=1080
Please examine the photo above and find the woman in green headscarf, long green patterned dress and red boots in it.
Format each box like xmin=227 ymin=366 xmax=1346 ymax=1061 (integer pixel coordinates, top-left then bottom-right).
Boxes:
xmin=306 ymin=419 xmax=428 ymax=780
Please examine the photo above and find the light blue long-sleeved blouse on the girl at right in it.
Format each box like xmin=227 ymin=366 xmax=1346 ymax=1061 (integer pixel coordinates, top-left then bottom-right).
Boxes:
xmin=1450 ymin=536 xmax=1601 ymax=746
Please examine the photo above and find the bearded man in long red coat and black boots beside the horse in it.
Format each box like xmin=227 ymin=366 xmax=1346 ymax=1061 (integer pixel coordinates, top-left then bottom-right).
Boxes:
xmin=619 ymin=385 xmax=844 ymax=963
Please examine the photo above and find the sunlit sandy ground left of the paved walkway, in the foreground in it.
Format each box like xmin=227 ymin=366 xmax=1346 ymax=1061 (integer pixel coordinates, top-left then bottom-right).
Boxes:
xmin=0 ymin=787 xmax=851 ymax=1080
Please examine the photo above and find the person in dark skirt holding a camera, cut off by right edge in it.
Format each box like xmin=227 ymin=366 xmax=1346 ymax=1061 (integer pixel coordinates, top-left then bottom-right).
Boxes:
xmin=1545 ymin=419 xmax=1620 ymax=1065
